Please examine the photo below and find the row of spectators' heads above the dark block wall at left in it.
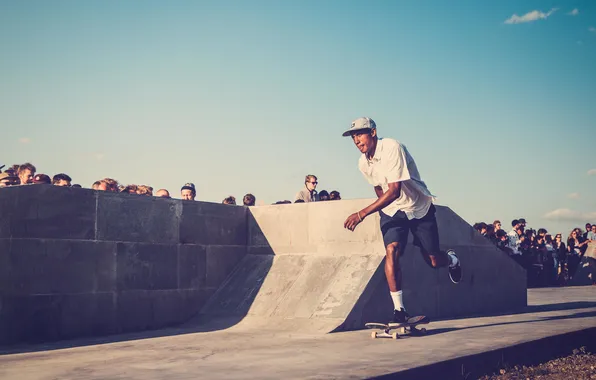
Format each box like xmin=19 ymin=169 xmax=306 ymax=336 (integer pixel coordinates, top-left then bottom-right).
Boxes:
xmin=0 ymin=162 xmax=341 ymax=206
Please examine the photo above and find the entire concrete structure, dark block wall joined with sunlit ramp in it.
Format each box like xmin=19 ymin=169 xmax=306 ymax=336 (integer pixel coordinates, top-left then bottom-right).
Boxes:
xmin=0 ymin=185 xmax=527 ymax=345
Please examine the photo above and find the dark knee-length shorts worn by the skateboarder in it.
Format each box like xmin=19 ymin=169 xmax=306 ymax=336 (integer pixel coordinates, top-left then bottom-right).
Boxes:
xmin=379 ymin=205 xmax=440 ymax=256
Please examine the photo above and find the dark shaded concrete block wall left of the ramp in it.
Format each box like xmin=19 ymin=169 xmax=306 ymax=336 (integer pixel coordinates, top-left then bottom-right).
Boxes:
xmin=0 ymin=185 xmax=247 ymax=344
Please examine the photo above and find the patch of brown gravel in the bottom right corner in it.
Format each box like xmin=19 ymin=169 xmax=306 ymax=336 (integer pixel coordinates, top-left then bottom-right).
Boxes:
xmin=480 ymin=347 xmax=596 ymax=380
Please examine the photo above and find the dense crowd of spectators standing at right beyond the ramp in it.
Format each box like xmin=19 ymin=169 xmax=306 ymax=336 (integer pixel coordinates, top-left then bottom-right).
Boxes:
xmin=474 ymin=218 xmax=596 ymax=287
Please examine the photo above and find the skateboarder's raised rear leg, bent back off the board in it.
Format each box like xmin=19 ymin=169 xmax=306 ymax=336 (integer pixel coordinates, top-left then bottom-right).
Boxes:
xmin=410 ymin=205 xmax=461 ymax=283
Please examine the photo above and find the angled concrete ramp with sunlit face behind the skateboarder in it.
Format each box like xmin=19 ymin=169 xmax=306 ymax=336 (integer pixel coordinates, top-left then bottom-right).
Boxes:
xmin=201 ymin=199 xmax=527 ymax=333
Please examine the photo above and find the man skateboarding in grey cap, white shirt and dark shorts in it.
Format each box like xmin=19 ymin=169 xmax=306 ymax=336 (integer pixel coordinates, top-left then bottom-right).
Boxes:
xmin=342 ymin=117 xmax=462 ymax=323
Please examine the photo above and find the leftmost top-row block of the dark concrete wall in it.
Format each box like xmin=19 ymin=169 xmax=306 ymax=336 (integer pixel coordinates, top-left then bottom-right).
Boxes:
xmin=0 ymin=185 xmax=97 ymax=239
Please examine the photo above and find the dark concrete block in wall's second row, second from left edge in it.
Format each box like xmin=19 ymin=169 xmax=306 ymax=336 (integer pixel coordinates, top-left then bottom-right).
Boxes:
xmin=116 ymin=243 xmax=178 ymax=291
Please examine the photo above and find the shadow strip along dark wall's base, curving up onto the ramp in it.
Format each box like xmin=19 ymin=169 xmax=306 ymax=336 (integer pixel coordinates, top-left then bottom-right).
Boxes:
xmin=0 ymin=211 xmax=275 ymax=356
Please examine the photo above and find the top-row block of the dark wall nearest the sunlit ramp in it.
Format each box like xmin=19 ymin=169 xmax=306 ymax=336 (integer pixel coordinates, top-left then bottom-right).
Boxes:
xmin=180 ymin=201 xmax=247 ymax=245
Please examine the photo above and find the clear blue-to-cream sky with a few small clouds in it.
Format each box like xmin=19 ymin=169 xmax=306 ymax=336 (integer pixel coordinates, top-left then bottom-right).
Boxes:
xmin=0 ymin=0 xmax=596 ymax=234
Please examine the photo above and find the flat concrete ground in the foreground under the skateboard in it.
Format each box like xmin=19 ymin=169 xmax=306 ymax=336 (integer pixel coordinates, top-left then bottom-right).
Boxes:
xmin=0 ymin=287 xmax=596 ymax=380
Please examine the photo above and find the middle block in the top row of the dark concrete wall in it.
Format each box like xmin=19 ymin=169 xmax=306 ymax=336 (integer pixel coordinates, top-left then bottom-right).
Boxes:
xmin=97 ymin=192 xmax=182 ymax=244
